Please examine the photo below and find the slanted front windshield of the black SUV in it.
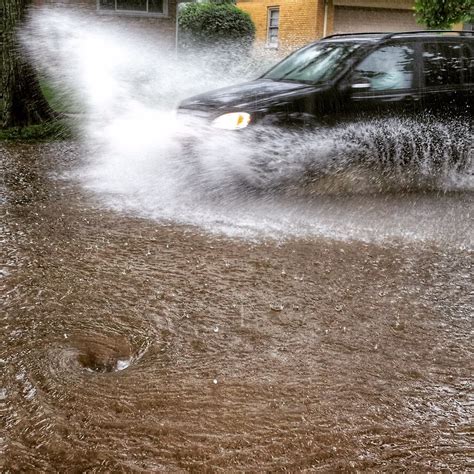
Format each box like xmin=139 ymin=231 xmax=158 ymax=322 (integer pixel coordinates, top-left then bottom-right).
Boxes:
xmin=263 ymin=42 xmax=360 ymax=84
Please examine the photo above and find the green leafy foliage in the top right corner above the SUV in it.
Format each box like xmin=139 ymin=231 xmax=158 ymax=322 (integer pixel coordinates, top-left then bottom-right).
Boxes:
xmin=415 ymin=0 xmax=474 ymax=30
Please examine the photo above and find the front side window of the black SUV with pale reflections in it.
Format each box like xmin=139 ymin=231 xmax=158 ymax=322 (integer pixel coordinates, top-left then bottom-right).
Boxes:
xmin=353 ymin=44 xmax=415 ymax=91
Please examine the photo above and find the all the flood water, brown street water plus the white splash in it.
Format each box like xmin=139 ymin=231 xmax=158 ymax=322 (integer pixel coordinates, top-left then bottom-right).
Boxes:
xmin=0 ymin=10 xmax=474 ymax=472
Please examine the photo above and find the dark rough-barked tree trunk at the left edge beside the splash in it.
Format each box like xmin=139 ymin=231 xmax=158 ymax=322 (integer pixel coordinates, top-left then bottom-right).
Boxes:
xmin=0 ymin=0 xmax=55 ymax=128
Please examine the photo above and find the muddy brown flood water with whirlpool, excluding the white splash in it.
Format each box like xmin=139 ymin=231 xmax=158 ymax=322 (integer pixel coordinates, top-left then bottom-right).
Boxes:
xmin=0 ymin=143 xmax=474 ymax=472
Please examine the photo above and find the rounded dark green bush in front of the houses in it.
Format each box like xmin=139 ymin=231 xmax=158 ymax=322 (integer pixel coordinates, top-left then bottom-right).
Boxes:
xmin=178 ymin=0 xmax=255 ymax=48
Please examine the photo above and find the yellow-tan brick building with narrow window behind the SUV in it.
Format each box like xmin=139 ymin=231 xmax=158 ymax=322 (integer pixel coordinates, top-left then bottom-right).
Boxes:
xmin=237 ymin=0 xmax=422 ymax=50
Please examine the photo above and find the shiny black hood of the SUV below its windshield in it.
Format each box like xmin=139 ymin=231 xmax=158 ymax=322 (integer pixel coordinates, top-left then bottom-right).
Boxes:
xmin=179 ymin=79 xmax=314 ymax=111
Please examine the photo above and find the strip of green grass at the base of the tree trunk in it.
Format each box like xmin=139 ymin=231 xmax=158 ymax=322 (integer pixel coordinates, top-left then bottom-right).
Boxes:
xmin=0 ymin=120 xmax=75 ymax=142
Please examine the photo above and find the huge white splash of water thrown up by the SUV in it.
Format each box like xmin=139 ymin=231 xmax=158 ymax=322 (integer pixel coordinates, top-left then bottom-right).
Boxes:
xmin=23 ymin=10 xmax=474 ymax=243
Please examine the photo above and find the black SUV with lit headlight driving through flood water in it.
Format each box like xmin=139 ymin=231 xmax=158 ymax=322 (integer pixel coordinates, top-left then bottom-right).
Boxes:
xmin=178 ymin=31 xmax=474 ymax=130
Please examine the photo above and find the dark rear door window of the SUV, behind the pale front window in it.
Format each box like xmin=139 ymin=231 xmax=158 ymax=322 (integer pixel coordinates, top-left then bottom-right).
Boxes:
xmin=423 ymin=42 xmax=463 ymax=87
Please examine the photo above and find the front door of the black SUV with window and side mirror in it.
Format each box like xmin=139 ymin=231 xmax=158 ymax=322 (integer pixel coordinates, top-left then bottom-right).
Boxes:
xmin=343 ymin=41 xmax=420 ymax=120
